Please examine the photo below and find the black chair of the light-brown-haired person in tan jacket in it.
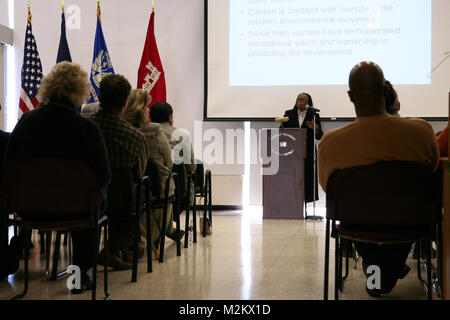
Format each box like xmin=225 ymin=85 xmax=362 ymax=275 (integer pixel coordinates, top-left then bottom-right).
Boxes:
xmin=146 ymin=159 xmax=181 ymax=263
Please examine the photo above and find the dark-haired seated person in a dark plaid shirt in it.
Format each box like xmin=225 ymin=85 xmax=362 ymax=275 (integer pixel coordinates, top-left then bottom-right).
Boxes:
xmin=90 ymin=75 xmax=148 ymax=270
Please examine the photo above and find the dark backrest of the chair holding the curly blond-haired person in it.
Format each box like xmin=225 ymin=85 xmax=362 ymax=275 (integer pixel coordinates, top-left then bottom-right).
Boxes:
xmin=3 ymin=157 xmax=101 ymax=218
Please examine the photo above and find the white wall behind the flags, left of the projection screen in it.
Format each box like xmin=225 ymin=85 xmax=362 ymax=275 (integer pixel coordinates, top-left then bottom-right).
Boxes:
xmin=11 ymin=0 xmax=204 ymax=136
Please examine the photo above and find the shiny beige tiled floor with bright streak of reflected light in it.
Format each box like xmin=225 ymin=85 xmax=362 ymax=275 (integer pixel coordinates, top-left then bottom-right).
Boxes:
xmin=0 ymin=208 xmax=436 ymax=300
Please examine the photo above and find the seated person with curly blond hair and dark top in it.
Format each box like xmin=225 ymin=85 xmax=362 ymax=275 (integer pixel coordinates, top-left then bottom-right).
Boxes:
xmin=6 ymin=62 xmax=111 ymax=293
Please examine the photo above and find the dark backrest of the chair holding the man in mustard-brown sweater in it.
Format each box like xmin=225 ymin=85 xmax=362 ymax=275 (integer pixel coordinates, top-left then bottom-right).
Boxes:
xmin=327 ymin=161 xmax=442 ymax=227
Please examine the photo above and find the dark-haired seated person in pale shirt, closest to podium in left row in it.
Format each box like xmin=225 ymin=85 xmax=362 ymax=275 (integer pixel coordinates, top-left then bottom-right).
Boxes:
xmin=150 ymin=102 xmax=197 ymax=203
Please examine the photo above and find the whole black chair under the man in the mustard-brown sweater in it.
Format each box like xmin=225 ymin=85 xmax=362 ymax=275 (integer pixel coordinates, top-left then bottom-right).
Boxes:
xmin=324 ymin=161 xmax=442 ymax=300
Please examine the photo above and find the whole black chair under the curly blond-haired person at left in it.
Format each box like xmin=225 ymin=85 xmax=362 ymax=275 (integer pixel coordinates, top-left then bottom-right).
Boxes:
xmin=2 ymin=157 xmax=110 ymax=300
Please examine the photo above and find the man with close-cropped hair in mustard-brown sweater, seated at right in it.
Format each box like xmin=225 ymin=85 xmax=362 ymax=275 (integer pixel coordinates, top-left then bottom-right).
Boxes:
xmin=318 ymin=62 xmax=438 ymax=296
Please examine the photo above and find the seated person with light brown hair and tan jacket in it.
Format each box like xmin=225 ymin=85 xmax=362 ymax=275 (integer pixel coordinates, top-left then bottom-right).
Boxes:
xmin=123 ymin=89 xmax=184 ymax=256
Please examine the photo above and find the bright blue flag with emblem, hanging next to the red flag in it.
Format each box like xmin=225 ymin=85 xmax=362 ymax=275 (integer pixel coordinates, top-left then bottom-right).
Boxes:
xmin=89 ymin=6 xmax=114 ymax=103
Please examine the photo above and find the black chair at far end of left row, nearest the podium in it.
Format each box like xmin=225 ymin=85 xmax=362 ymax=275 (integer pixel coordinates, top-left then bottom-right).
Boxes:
xmin=192 ymin=160 xmax=212 ymax=238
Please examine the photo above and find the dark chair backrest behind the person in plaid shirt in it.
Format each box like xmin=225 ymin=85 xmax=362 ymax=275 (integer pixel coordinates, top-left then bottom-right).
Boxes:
xmin=106 ymin=167 xmax=134 ymax=213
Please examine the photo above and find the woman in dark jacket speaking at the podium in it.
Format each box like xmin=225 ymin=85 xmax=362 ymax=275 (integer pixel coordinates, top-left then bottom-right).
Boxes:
xmin=282 ymin=93 xmax=323 ymax=203
